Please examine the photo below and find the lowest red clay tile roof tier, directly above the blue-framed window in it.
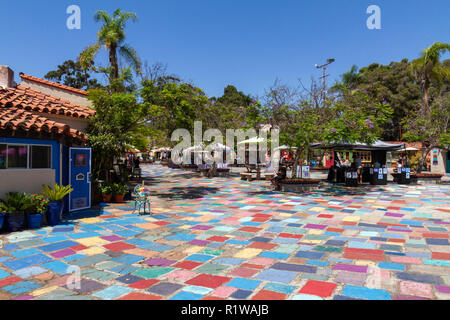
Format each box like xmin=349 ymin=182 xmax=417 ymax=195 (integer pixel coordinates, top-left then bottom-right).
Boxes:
xmin=0 ymin=107 xmax=87 ymax=142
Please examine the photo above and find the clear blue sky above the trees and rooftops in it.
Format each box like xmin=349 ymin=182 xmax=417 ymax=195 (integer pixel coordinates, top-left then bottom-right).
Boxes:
xmin=0 ymin=0 xmax=450 ymax=96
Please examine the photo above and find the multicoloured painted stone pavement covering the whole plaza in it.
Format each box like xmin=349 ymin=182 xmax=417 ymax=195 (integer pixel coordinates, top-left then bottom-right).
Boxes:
xmin=0 ymin=165 xmax=450 ymax=300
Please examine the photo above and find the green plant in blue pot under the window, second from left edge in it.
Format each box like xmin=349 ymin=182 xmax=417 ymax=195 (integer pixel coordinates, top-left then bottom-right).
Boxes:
xmin=5 ymin=192 xmax=32 ymax=232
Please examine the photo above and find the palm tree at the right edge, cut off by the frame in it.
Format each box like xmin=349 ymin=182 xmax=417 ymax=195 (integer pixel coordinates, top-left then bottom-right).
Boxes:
xmin=411 ymin=42 xmax=450 ymax=116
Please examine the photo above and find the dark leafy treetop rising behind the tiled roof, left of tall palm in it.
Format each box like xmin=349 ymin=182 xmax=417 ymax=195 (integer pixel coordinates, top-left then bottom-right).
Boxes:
xmin=44 ymin=60 xmax=102 ymax=90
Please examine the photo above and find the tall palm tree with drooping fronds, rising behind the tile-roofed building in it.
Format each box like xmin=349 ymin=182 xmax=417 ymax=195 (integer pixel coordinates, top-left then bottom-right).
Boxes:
xmin=79 ymin=9 xmax=141 ymax=81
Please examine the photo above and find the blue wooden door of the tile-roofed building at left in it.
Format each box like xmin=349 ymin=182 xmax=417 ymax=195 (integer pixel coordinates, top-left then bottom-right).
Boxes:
xmin=69 ymin=148 xmax=92 ymax=212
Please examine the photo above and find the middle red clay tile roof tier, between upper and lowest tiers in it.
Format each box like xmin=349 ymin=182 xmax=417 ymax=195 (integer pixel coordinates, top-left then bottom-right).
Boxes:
xmin=0 ymin=85 xmax=95 ymax=119
